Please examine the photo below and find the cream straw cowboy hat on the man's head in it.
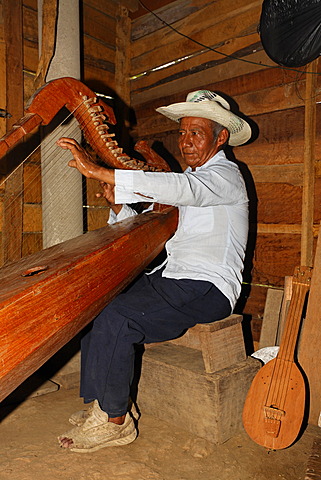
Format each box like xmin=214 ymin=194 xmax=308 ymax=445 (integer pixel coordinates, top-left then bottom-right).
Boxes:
xmin=156 ymin=90 xmax=251 ymax=147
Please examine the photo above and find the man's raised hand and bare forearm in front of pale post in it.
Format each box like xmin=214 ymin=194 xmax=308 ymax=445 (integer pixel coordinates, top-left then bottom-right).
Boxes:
xmin=57 ymin=137 xmax=115 ymax=186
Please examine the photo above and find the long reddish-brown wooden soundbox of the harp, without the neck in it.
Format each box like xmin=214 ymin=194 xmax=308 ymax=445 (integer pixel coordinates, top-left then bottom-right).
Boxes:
xmin=0 ymin=208 xmax=177 ymax=401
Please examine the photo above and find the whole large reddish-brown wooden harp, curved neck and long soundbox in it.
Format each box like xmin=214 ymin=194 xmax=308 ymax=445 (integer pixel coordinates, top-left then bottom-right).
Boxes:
xmin=0 ymin=78 xmax=177 ymax=401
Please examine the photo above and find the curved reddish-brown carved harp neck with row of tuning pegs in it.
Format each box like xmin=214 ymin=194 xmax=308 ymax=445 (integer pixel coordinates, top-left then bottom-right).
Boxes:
xmin=0 ymin=77 xmax=170 ymax=175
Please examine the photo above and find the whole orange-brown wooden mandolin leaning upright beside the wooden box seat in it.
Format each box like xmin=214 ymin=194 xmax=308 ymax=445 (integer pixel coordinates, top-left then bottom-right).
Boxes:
xmin=243 ymin=267 xmax=312 ymax=449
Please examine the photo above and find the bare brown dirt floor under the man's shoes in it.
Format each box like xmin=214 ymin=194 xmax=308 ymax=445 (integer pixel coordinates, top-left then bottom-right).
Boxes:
xmin=0 ymin=389 xmax=321 ymax=480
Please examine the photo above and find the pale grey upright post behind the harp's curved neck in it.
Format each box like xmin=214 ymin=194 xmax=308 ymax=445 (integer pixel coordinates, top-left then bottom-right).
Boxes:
xmin=38 ymin=0 xmax=83 ymax=248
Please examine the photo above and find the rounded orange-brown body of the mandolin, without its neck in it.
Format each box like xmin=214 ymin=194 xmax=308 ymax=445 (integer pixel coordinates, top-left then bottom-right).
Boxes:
xmin=243 ymin=357 xmax=305 ymax=450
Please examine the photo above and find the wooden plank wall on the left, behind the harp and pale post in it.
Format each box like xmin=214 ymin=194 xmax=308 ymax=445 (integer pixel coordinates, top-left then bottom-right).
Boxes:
xmin=0 ymin=0 xmax=127 ymax=265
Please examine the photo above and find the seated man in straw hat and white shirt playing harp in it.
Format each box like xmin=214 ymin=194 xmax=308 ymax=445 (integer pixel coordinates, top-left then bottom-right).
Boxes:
xmin=58 ymin=90 xmax=251 ymax=452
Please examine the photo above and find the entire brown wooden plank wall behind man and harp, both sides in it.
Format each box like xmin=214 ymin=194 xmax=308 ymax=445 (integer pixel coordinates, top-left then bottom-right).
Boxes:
xmin=0 ymin=0 xmax=321 ymax=341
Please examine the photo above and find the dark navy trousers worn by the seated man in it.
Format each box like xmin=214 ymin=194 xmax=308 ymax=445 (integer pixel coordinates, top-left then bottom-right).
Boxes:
xmin=80 ymin=270 xmax=231 ymax=417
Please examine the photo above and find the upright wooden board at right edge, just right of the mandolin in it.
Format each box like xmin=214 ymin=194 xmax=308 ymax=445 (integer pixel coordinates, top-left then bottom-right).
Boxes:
xmin=298 ymin=232 xmax=321 ymax=425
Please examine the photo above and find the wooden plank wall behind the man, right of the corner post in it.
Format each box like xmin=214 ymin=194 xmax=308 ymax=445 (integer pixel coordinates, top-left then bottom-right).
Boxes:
xmin=127 ymin=0 xmax=321 ymax=342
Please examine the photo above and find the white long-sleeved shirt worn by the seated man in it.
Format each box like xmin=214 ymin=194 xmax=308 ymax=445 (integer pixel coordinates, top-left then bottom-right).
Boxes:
xmin=110 ymin=151 xmax=248 ymax=308
